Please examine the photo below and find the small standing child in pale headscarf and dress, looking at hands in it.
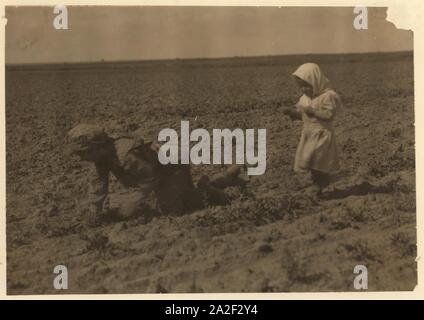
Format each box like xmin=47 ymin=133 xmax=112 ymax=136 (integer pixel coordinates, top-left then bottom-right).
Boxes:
xmin=284 ymin=63 xmax=341 ymax=193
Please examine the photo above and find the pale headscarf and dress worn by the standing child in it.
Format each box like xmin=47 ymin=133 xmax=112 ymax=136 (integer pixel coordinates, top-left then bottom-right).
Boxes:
xmin=294 ymin=64 xmax=341 ymax=174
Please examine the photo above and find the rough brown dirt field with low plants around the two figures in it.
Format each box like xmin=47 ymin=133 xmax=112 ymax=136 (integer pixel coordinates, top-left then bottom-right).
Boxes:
xmin=6 ymin=53 xmax=416 ymax=294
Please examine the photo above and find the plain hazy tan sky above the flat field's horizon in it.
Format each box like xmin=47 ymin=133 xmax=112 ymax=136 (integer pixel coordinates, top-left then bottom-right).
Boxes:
xmin=5 ymin=6 xmax=413 ymax=64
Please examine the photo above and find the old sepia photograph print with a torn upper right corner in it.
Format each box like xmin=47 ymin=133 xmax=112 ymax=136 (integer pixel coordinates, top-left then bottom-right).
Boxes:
xmin=4 ymin=5 xmax=417 ymax=296
